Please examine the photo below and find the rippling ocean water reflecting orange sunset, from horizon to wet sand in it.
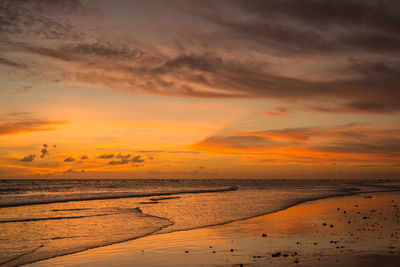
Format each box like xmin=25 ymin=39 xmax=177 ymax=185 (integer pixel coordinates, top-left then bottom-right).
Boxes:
xmin=0 ymin=179 xmax=399 ymax=266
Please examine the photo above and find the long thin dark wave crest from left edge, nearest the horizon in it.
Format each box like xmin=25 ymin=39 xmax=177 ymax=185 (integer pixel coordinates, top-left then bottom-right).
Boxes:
xmin=0 ymin=186 xmax=238 ymax=208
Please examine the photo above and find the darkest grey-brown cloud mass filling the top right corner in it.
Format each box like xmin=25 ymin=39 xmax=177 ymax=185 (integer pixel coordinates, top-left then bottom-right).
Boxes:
xmin=193 ymin=0 xmax=400 ymax=53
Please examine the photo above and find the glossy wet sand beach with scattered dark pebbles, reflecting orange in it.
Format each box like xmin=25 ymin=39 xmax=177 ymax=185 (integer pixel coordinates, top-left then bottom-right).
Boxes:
xmin=26 ymin=192 xmax=400 ymax=266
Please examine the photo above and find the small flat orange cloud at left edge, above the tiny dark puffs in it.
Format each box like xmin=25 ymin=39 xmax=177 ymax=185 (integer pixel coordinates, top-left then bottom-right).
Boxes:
xmin=0 ymin=118 xmax=66 ymax=135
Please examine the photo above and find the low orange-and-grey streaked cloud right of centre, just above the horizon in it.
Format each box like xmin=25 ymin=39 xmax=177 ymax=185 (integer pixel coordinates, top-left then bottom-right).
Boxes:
xmin=192 ymin=124 xmax=400 ymax=165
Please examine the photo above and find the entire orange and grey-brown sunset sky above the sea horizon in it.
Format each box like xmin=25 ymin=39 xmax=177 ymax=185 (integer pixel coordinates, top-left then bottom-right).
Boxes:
xmin=0 ymin=0 xmax=400 ymax=179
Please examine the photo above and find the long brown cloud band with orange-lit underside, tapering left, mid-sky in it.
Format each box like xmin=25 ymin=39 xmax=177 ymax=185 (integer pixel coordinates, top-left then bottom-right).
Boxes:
xmin=72 ymin=54 xmax=400 ymax=113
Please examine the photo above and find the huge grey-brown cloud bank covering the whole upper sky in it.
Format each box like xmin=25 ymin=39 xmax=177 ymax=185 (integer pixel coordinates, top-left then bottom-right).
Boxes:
xmin=0 ymin=0 xmax=400 ymax=116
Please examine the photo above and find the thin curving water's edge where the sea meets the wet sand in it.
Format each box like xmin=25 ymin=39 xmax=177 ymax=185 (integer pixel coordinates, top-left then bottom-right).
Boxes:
xmin=24 ymin=189 xmax=399 ymax=266
